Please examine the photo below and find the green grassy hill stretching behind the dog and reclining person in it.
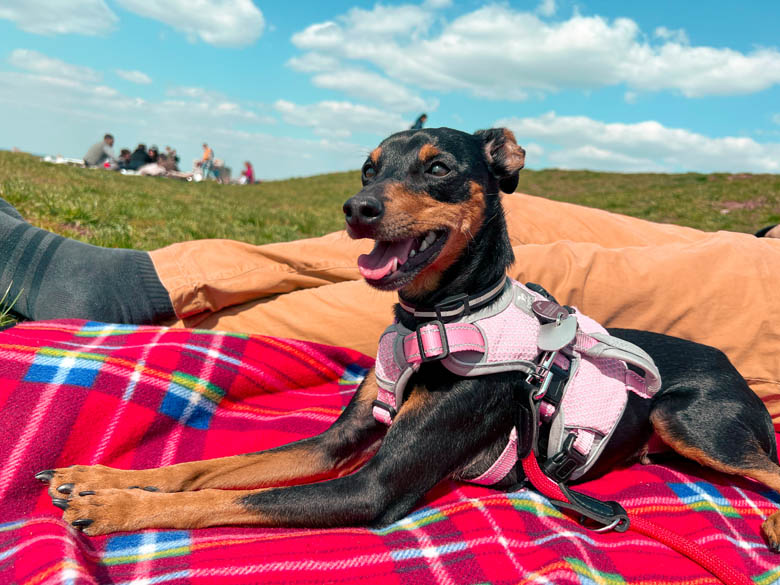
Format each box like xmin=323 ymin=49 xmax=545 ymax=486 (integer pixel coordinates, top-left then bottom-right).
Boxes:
xmin=0 ymin=152 xmax=780 ymax=250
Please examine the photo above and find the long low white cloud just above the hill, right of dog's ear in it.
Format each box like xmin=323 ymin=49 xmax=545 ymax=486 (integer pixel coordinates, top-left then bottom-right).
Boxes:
xmin=496 ymin=112 xmax=780 ymax=173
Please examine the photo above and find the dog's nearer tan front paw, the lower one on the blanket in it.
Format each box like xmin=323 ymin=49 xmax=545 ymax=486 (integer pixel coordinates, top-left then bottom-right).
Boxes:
xmin=62 ymin=489 xmax=152 ymax=536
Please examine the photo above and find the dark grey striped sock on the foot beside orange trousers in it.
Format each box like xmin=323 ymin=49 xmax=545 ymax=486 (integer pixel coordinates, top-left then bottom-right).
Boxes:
xmin=0 ymin=199 xmax=174 ymax=323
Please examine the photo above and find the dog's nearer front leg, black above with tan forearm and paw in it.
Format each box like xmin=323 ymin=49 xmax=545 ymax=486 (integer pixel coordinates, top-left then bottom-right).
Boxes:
xmin=65 ymin=384 xmax=494 ymax=535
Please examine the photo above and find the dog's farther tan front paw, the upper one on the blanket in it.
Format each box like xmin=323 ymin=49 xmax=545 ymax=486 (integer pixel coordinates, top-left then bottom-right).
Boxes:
xmin=35 ymin=465 xmax=159 ymax=500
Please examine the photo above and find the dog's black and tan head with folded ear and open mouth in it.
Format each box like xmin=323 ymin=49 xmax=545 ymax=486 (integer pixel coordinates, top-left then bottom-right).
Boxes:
xmin=344 ymin=128 xmax=525 ymax=299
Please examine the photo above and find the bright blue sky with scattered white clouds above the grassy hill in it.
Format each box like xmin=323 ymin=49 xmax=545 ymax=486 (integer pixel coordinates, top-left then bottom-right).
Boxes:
xmin=0 ymin=0 xmax=780 ymax=179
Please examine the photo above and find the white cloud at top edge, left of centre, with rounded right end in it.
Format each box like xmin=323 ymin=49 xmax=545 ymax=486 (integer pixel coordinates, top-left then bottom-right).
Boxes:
xmin=117 ymin=0 xmax=265 ymax=47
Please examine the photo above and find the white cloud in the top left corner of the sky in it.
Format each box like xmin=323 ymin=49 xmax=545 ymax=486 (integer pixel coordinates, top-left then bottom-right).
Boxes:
xmin=0 ymin=0 xmax=118 ymax=35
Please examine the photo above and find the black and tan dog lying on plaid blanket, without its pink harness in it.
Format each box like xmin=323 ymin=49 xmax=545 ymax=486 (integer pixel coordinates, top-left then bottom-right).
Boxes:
xmin=36 ymin=128 xmax=780 ymax=551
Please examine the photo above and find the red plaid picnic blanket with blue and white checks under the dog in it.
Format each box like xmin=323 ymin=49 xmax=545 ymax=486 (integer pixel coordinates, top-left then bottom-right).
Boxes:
xmin=0 ymin=321 xmax=780 ymax=585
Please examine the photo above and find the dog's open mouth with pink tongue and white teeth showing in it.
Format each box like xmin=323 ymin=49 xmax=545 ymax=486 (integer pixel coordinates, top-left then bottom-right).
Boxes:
xmin=358 ymin=230 xmax=447 ymax=290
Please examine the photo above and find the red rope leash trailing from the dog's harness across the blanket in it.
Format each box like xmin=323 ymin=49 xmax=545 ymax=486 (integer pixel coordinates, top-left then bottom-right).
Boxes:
xmin=523 ymin=452 xmax=754 ymax=585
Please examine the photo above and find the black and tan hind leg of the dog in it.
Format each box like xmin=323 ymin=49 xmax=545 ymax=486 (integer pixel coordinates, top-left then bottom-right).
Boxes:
xmin=650 ymin=372 xmax=780 ymax=552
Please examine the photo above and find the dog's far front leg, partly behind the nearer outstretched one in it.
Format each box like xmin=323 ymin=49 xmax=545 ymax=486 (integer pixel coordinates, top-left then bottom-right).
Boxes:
xmin=36 ymin=370 xmax=386 ymax=500
